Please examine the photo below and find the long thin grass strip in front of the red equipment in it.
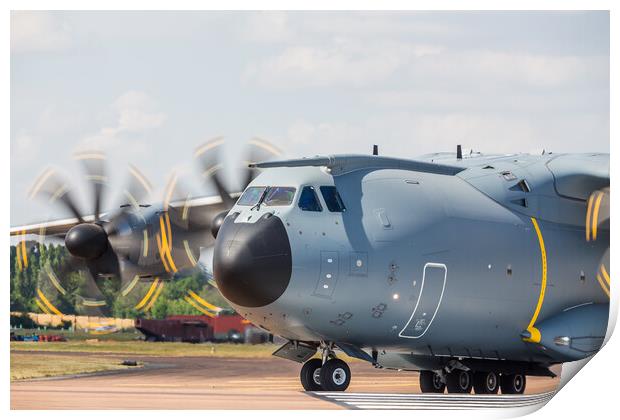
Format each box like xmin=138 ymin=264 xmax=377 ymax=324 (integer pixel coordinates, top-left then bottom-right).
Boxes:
xmin=11 ymin=339 xmax=278 ymax=358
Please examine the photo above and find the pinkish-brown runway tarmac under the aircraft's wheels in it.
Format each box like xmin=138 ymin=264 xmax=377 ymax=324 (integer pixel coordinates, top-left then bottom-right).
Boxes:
xmin=11 ymin=353 xmax=559 ymax=410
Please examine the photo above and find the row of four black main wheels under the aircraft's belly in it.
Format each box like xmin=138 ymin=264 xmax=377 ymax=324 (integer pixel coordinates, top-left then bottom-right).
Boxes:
xmin=420 ymin=369 xmax=526 ymax=394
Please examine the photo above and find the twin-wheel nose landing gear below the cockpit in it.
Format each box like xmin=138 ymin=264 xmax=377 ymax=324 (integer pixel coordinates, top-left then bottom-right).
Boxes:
xmin=299 ymin=347 xmax=351 ymax=392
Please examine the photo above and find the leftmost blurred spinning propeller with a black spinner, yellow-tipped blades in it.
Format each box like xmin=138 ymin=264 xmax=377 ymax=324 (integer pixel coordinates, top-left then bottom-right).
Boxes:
xmin=20 ymin=152 xmax=151 ymax=315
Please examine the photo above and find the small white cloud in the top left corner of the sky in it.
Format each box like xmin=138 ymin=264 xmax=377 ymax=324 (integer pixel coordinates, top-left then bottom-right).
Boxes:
xmin=11 ymin=11 xmax=72 ymax=53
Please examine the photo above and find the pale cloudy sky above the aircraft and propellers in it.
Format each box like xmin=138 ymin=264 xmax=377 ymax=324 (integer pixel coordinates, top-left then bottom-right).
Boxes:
xmin=10 ymin=11 xmax=610 ymax=226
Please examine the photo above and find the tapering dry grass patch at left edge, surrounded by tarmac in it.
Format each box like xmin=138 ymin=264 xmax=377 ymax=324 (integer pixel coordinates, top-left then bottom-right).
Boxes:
xmin=11 ymin=352 xmax=135 ymax=381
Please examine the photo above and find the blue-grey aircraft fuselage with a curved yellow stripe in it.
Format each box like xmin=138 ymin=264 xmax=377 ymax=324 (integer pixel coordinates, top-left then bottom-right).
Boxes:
xmin=214 ymin=154 xmax=609 ymax=369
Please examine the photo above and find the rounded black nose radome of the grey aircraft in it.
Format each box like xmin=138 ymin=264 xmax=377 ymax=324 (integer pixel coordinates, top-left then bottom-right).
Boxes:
xmin=213 ymin=214 xmax=292 ymax=308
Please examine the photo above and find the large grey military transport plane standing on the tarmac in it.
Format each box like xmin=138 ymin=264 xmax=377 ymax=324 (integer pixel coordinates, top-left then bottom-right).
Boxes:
xmin=14 ymin=139 xmax=610 ymax=394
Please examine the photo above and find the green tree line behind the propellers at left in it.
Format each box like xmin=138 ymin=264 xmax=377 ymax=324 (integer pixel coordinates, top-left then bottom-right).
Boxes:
xmin=10 ymin=244 xmax=229 ymax=318
